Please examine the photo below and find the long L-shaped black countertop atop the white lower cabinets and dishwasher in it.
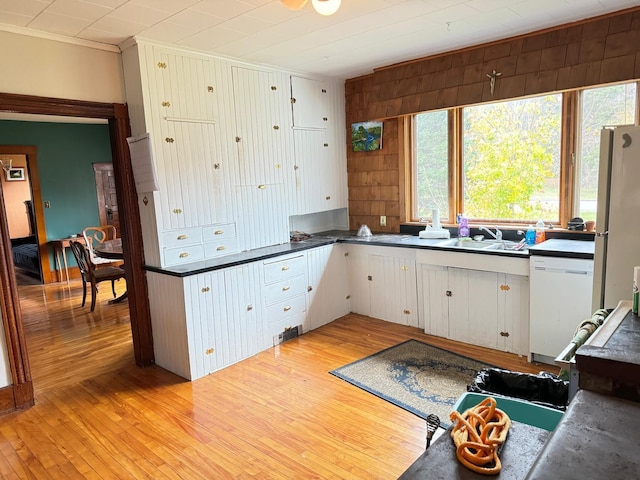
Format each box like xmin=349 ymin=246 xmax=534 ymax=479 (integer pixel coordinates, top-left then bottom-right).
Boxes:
xmin=144 ymin=230 xmax=593 ymax=277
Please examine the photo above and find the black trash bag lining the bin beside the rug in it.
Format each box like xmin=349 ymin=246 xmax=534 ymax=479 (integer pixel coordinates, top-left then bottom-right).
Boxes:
xmin=467 ymin=368 xmax=569 ymax=411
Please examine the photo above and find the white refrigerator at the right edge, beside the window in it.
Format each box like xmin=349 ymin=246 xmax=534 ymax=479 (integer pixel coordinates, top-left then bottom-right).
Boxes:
xmin=592 ymin=126 xmax=640 ymax=311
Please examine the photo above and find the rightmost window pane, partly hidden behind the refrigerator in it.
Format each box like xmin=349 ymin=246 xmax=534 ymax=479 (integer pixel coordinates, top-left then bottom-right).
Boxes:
xmin=576 ymin=83 xmax=637 ymax=220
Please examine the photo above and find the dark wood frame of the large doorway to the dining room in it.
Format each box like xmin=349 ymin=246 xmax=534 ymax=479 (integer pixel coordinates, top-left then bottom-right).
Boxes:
xmin=0 ymin=93 xmax=154 ymax=412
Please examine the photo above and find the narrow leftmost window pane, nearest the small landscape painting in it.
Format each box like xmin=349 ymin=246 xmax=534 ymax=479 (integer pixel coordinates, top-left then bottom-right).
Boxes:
xmin=413 ymin=110 xmax=449 ymax=221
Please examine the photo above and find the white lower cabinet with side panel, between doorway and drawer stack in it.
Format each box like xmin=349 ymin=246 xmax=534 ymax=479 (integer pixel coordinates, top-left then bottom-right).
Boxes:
xmin=147 ymin=263 xmax=262 ymax=380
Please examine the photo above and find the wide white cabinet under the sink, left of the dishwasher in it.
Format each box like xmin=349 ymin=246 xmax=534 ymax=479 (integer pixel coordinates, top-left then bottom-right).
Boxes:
xmin=418 ymin=264 xmax=529 ymax=355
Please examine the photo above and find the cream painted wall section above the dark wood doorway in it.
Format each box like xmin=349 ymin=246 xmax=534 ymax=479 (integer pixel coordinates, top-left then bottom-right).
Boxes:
xmin=0 ymin=31 xmax=125 ymax=103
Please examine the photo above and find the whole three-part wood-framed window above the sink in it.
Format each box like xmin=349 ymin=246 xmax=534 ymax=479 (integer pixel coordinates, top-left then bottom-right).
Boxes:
xmin=411 ymin=83 xmax=638 ymax=225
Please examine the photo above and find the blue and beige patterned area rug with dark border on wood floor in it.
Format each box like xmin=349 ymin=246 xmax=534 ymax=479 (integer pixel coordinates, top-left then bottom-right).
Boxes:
xmin=329 ymin=340 xmax=493 ymax=428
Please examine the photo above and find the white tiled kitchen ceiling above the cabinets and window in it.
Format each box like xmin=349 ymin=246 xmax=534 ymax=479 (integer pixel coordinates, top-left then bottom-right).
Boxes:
xmin=0 ymin=0 xmax=640 ymax=78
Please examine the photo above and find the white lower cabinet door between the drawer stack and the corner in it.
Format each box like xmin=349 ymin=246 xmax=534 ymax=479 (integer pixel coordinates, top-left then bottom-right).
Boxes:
xmin=305 ymin=244 xmax=350 ymax=330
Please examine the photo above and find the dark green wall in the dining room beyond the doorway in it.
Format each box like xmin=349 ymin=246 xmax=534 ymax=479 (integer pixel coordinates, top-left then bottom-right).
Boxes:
xmin=0 ymin=120 xmax=111 ymax=267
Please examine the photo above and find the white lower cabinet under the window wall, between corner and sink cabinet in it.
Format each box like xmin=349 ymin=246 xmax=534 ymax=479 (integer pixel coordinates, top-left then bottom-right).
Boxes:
xmin=348 ymin=246 xmax=421 ymax=327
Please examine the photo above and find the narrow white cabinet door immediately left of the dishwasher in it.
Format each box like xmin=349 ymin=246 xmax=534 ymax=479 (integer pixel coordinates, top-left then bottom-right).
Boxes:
xmin=498 ymin=274 xmax=529 ymax=355
